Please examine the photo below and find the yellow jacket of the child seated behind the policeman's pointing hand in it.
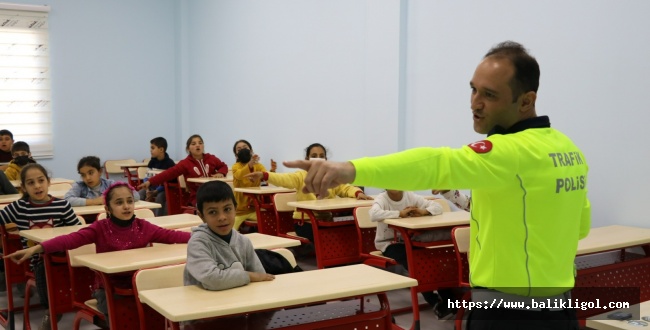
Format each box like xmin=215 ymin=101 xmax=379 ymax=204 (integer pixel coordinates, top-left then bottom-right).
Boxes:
xmin=268 ymin=171 xmax=361 ymax=219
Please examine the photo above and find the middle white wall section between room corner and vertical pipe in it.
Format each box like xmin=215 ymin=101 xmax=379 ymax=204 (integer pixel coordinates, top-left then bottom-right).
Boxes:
xmin=182 ymin=0 xmax=399 ymax=171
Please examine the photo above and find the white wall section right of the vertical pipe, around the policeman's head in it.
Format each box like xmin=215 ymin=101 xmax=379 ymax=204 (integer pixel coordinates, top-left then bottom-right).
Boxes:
xmin=406 ymin=0 xmax=650 ymax=227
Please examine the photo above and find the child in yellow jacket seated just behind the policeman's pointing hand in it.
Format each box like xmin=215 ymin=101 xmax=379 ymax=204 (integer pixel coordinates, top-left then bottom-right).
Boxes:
xmin=245 ymin=143 xmax=372 ymax=242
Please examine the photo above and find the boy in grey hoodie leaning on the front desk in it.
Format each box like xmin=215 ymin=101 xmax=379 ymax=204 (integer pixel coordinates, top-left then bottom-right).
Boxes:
xmin=184 ymin=181 xmax=275 ymax=291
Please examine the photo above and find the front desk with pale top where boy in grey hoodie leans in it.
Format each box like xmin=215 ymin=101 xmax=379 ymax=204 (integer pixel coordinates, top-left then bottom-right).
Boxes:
xmin=139 ymin=265 xmax=417 ymax=329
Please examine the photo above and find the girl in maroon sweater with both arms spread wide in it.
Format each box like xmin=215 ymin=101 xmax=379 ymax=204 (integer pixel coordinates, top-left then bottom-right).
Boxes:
xmin=7 ymin=181 xmax=190 ymax=319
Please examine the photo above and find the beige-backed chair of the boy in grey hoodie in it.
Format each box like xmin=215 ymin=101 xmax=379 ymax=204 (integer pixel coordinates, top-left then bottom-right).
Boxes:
xmin=133 ymin=264 xmax=185 ymax=330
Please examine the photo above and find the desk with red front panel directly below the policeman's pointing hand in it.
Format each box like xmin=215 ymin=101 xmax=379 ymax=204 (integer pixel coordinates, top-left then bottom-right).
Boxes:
xmin=287 ymin=198 xmax=374 ymax=268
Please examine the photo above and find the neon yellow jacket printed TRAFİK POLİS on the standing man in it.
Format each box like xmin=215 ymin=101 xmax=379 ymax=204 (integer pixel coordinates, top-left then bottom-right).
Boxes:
xmin=352 ymin=128 xmax=591 ymax=296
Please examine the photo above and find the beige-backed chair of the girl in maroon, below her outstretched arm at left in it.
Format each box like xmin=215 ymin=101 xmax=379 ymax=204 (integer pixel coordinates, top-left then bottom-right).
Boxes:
xmin=67 ymin=244 xmax=101 ymax=329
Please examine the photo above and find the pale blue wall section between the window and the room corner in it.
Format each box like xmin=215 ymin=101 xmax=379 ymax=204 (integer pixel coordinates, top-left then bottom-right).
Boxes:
xmin=13 ymin=0 xmax=178 ymax=179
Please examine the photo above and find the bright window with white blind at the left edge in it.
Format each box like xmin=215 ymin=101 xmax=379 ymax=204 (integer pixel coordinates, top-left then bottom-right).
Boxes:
xmin=0 ymin=4 xmax=54 ymax=158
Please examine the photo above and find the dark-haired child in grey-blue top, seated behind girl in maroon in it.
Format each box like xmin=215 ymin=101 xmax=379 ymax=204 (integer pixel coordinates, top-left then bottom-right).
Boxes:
xmin=63 ymin=156 xmax=140 ymax=206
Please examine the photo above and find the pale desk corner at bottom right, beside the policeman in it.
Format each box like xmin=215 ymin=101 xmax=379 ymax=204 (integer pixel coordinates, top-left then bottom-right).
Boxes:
xmin=587 ymin=301 xmax=650 ymax=330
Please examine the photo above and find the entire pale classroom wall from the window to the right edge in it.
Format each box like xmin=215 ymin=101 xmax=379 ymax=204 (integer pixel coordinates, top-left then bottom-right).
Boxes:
xmin=5 ymin=0 xmax=650 ymax=227
